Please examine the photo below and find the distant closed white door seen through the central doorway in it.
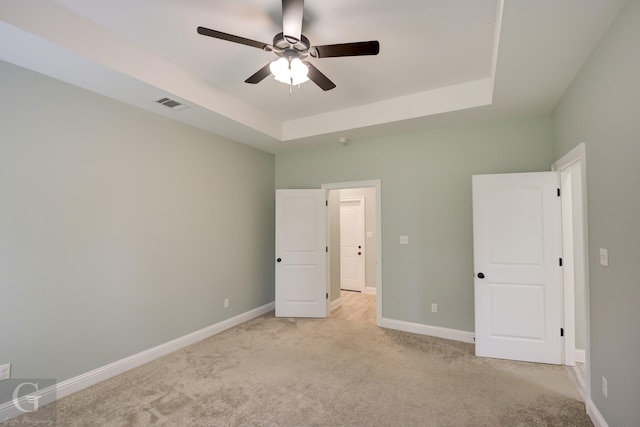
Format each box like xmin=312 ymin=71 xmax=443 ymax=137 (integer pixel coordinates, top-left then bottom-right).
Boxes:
xmin=340 ymin=198 xmax=365 ymax=292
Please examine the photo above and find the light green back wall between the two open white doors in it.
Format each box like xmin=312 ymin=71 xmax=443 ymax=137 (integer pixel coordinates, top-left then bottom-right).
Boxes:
xmin=276 ymin=116 xmax=552 ymax=331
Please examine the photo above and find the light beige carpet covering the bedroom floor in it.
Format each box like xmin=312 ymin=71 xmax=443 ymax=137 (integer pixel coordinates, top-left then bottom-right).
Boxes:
xmin=2 ymin=314 xmax=592 ymax=427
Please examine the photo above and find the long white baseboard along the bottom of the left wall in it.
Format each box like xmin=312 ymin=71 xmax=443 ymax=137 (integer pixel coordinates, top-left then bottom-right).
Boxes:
xmin=0 ymin=302 xmax=275 ymax=422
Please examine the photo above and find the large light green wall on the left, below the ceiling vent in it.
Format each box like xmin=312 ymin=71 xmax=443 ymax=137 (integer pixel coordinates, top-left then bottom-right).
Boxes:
xmin=0 ymin=62 xmax=275 ymax=403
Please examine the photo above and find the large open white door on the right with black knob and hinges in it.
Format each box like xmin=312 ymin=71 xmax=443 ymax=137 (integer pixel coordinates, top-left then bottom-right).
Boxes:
xmin=473 ymin=172 xmax=563 ymax=364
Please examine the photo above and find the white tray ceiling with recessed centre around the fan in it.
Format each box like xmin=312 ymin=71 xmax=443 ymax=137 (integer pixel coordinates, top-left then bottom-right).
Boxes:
xmin=0 ymin=0 xmax=624 ymax=152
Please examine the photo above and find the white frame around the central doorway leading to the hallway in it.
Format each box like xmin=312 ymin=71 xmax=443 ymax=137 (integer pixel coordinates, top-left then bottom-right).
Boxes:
xmin=320 ymin=179 xmax=382 ymax=327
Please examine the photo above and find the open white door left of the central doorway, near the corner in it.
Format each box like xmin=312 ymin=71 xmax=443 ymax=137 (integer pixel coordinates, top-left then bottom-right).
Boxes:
xmin=275 ymin=190 xmax=327 ymax=317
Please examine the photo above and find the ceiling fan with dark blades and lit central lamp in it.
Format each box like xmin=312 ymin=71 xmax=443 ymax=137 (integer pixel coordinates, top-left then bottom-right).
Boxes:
xmin=198 ymin=0 xmax=380 ymax=90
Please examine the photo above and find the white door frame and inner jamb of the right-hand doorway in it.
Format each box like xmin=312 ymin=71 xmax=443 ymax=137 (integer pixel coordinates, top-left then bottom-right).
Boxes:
xmin=551 ymin=142 xmax=591 ymax=394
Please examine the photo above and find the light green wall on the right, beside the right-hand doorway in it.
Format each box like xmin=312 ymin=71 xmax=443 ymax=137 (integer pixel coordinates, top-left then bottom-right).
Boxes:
xmin=552 ymin=0 xmax=640 ymax=426
